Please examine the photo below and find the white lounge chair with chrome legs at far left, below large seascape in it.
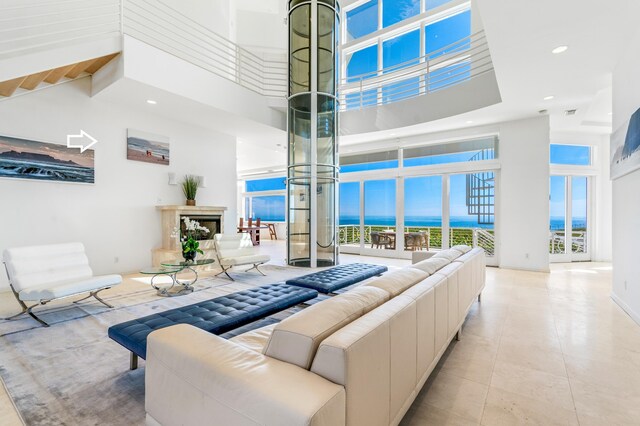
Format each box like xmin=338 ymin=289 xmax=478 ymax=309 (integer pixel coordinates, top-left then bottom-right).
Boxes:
xmin=3 ymin=243 xmax=122 ymax=327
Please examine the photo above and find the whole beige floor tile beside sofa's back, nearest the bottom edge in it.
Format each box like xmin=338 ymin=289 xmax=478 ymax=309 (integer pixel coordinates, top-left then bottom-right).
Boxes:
xmin=414 ymin=371 xmax=488 ymax=422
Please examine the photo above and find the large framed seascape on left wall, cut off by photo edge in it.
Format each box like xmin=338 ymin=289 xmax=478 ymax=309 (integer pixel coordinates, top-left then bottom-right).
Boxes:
xmin=0 ymin=135 xmax=95 ymax=183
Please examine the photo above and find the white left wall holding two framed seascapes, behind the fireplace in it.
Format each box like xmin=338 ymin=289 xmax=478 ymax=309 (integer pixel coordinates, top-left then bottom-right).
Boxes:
xmin=0 ymin=78 xmax=236 ymax=289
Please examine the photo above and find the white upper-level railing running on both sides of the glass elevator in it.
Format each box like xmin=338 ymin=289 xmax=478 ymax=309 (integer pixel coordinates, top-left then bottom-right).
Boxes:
xmin=0 ymin=0 xmax=493 ymax=106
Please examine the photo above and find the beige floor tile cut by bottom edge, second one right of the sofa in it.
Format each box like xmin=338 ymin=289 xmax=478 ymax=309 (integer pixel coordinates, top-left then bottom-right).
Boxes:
xmin=482 ymin=387 xmax=578 ymax=426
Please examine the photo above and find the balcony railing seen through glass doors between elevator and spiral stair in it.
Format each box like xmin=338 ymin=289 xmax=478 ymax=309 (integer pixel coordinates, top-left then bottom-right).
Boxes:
xmin=338 ymin=225 xmax=495 ymax=256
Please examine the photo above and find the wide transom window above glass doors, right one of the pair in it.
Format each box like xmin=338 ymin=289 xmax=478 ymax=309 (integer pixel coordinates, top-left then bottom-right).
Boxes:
xmin=403 ymin=137 xmax=498 ymax=167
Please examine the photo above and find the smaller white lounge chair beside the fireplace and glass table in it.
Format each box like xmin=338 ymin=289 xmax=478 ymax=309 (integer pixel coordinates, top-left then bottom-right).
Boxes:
xmin=213 ymin=233 xmax=271 ymax=281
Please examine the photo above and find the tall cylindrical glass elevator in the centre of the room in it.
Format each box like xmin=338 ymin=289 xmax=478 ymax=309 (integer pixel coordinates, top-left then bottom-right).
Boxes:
xmin=287 ymin=0 xmax=340 ymax=267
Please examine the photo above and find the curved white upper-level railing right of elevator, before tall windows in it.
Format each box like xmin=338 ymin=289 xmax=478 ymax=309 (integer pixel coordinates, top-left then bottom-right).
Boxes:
xmin=340 ymin=30 xmax=493 ymax=110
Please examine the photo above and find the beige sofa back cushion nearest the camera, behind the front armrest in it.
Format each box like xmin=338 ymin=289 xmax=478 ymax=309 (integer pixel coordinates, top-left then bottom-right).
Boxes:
xmin=264 ymin=286 xmax=389 ymax=370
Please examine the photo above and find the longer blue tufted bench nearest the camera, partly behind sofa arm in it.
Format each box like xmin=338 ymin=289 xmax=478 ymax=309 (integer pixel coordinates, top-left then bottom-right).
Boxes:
xmin=109 ymin=283 xmax=318 ymax=370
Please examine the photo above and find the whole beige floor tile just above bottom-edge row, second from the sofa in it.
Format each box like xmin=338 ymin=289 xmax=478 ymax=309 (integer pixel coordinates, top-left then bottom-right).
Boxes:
xmin=491 ymin=361 xmax=574 ymax=410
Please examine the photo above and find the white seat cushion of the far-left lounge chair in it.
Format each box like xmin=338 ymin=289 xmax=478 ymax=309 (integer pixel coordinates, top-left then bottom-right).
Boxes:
xmin=18 ymin=275 xmax=122 ymax=301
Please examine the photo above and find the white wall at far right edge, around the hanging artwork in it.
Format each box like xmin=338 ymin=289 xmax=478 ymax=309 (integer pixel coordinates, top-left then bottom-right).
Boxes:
xmin=612 ymin=28 xmax=640 ymax=323
